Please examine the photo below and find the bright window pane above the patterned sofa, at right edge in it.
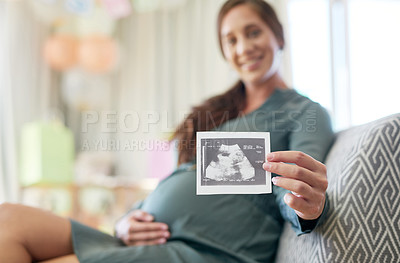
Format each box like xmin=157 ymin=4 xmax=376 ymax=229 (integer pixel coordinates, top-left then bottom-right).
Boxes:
xmin=349 ymin=0 xmax=400 ymax=124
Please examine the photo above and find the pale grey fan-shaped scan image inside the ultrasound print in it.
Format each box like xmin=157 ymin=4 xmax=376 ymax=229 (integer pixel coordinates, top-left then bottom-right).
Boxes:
xmin=205 ymin=144 xmax=255 ymax=181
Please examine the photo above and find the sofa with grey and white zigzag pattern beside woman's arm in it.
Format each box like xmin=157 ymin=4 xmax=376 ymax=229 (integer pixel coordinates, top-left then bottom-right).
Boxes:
xmin=276 ymin=114 xmax=400 ymax=263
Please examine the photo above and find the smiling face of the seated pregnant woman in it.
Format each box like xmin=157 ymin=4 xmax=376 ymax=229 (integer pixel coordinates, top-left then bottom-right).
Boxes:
xmin=220 ymin=4 xmax=281 ymax=86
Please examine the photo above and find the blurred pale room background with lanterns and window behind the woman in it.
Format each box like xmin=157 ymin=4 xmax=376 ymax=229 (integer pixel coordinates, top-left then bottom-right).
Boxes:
xmin=0 ymin=0 xmax=400 ymax=235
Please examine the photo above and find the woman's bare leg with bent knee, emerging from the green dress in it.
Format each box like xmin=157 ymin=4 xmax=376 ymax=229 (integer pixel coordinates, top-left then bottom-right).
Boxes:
xmin=0 ymin=204 xmax=73 ymax=263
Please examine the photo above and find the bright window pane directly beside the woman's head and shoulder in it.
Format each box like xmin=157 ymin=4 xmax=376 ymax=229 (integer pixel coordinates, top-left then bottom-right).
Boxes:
xmin=288 ymin=0 xmax=333 ymax=111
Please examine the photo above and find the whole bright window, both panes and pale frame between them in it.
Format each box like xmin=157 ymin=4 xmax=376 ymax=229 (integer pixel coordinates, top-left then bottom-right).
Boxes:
xmin=288 ymin=0 xmax=400 ymax=130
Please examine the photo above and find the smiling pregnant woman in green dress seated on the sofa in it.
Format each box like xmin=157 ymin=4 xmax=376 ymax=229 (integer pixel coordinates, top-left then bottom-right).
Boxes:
xmin=0 ymin=0 xmax=333 ymax=263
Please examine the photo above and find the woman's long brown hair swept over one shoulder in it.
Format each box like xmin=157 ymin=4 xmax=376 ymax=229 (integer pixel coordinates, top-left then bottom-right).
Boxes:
xmin=172 ymin=0 xmax=285 ymax=164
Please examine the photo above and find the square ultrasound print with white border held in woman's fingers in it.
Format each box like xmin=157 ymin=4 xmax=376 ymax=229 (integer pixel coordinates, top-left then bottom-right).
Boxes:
xmin=197 ymin=132 xmax=271 ymax=194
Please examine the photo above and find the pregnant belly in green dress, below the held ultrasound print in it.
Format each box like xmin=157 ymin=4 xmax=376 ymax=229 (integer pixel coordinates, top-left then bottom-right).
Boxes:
xmin=142 ymin=167 xmax=281 ymax=262
